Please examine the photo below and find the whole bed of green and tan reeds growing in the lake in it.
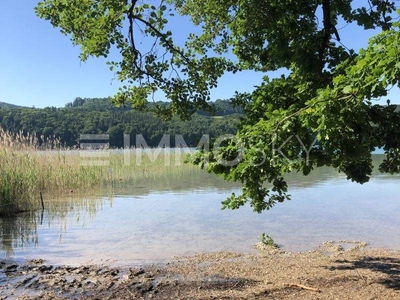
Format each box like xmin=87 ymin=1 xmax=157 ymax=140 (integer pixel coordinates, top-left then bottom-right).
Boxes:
xmin=0 ymin=130 xmax=195 ymax=216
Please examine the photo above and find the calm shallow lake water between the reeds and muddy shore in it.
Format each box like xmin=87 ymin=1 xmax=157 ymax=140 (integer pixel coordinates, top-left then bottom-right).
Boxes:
xmin=0 ymin=155 xmax=400 ymax=265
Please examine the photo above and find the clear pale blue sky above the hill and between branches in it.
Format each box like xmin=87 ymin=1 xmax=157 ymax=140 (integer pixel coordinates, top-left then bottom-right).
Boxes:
xmin=0 ymin=0 xmax=400 ymax=107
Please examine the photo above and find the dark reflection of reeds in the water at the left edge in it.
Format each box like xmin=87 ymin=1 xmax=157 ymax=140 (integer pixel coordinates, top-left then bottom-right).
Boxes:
xmin=0 ymin=213 xmax=41 ymax=258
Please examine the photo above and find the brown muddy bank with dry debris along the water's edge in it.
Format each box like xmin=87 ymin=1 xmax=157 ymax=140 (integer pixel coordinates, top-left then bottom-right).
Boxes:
xmin=0 ymin=242 xmax=400 ymax=299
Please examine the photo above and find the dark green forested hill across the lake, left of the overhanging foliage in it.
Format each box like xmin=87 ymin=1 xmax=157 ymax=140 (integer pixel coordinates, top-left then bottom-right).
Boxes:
xmin=0 ymin=98 xmax=242 ymax=147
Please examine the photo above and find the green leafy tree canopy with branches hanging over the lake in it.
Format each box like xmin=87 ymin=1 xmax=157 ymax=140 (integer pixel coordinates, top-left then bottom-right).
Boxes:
xmin=36 ymin=0 xmax=400 ymax=212
